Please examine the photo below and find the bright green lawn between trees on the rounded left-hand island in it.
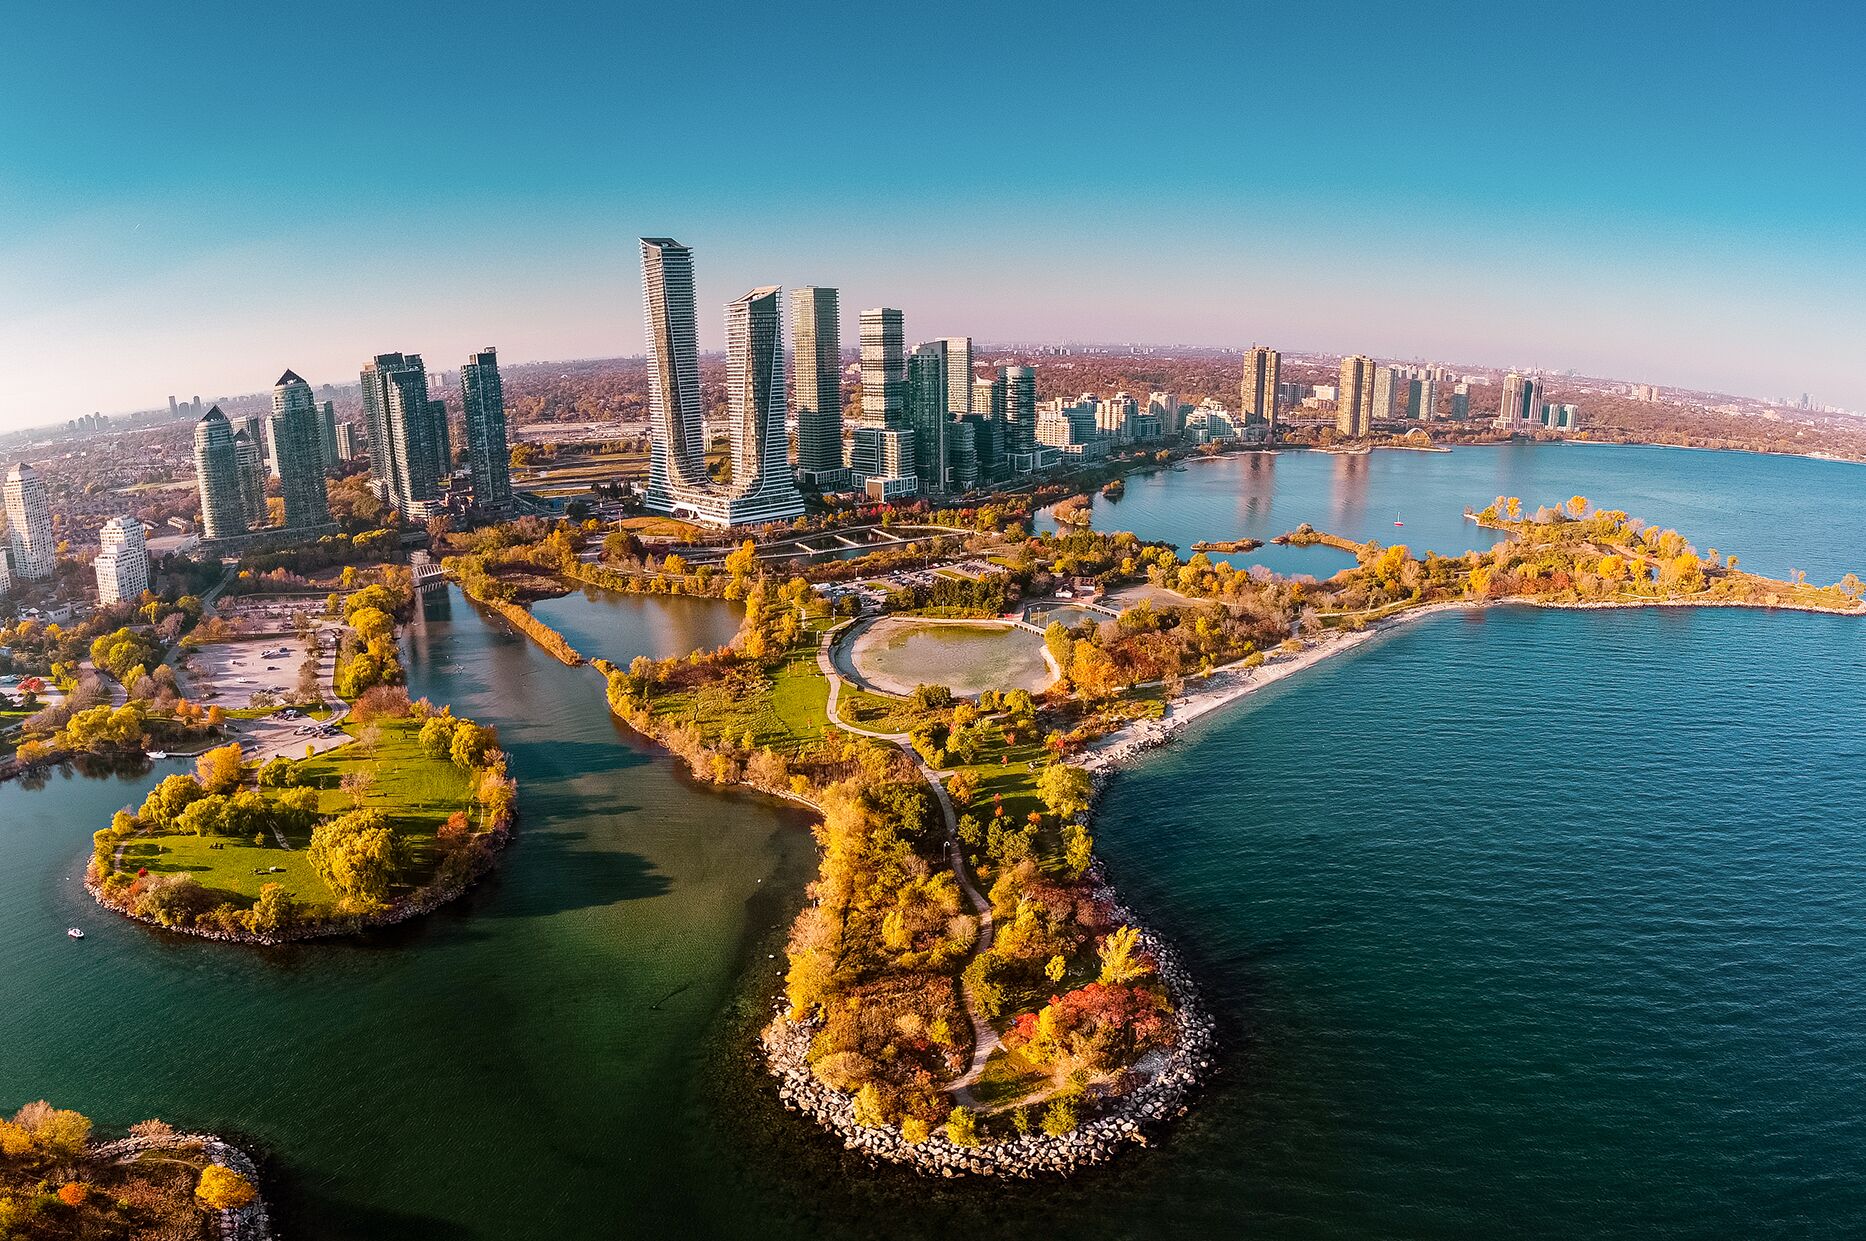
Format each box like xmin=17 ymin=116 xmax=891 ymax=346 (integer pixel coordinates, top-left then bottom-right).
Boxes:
xmin=123 ymin=720 xmax=472 ymax=907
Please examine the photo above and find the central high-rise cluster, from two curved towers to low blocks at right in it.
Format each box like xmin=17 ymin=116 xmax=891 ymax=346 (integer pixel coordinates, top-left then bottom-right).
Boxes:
xmin=642 ymin=237 xmax=1134 ymax=526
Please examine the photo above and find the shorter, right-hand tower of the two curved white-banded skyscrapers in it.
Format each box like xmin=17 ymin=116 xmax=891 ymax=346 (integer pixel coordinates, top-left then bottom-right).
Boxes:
xmin=715 ymin=286 xmax=804 ymax=526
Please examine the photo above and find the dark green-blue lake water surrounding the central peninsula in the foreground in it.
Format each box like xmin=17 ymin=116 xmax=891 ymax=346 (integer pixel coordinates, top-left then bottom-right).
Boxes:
xmin=0 ymin=448 xmax=1866 ymax=1241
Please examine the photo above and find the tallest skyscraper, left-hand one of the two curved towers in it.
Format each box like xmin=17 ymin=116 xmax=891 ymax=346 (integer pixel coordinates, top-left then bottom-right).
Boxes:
xmin=642 ymin=237 xmax=707 ymax=513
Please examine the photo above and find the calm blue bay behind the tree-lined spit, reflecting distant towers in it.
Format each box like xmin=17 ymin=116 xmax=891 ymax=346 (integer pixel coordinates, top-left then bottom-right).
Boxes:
xmin=1043 ymin=444 xmax=1866 ymax=582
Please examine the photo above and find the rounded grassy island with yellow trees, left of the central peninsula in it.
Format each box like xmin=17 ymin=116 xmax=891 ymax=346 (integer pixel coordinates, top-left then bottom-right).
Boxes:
xmin=88 ymin=687 xmax=515 ymax=942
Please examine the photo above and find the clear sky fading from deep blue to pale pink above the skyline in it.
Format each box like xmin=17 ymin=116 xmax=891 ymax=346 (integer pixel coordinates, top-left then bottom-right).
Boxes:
xmin=0 ymin=0 xmax=1866 ymax=427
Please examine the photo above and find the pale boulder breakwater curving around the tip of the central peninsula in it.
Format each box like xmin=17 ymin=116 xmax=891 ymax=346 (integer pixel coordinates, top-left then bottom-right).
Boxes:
xmin=763 ymin=905 xmax=1217 ymax=1178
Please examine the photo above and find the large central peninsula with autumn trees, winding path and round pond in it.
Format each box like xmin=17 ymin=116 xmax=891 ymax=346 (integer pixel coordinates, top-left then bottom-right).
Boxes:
xmin=452 ymin=496 xmax=1862 ymax=1176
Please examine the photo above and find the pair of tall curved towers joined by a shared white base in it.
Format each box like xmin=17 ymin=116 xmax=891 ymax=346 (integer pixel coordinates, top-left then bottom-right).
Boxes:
xmin=642 ymin=237 xmax=804 ymax=526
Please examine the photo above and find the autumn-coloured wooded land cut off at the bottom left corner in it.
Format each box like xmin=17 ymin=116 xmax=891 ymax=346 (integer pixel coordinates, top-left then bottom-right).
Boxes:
xmin=0 ymin=1101 xmax=272 ymax=1241
